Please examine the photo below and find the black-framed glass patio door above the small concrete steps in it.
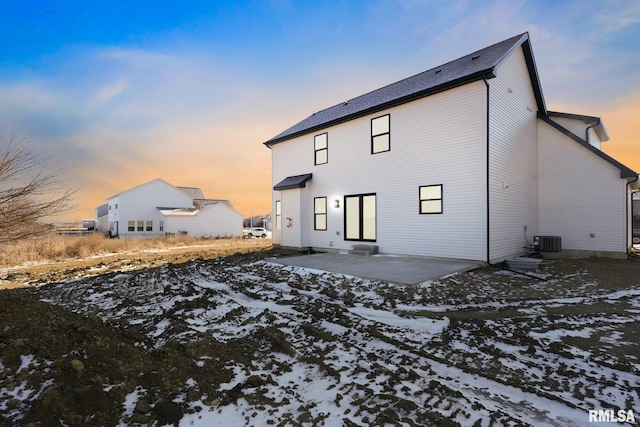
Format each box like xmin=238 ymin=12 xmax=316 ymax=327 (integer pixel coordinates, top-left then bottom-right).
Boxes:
xmin=344 ymin=194 xmax=376 ymax=241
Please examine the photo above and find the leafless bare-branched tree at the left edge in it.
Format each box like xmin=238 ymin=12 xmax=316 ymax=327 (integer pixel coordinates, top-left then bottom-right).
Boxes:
xmin=0 ymin=126 xmax=76 ymax=243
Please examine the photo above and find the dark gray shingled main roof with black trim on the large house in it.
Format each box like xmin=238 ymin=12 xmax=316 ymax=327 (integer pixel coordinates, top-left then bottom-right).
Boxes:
xmin=264 ymin=33 xmax=546 ymax=147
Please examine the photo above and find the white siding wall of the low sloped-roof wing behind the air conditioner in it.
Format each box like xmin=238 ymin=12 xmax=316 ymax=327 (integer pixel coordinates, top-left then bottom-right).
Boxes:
xmin=538 ymin=121 xmax=627 ymax=254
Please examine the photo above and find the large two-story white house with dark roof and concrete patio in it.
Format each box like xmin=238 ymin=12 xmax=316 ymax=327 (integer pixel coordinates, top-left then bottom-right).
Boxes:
xmin=264 ymin=33 xmax=638 ymax=262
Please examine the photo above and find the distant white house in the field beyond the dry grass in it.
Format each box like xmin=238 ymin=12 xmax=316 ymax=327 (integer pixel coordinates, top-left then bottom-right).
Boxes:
xmin=102 ymin=178 xmax=242 ymax=238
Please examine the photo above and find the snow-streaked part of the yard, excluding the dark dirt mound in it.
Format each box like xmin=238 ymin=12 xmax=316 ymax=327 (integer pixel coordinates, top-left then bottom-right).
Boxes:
xmin=0 ymin=258 xmax=640 ymax=426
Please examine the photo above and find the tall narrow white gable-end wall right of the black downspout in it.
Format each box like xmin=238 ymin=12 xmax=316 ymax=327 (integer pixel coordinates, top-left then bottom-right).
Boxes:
xmin=488 ymin=49 xmax=538 ymax=261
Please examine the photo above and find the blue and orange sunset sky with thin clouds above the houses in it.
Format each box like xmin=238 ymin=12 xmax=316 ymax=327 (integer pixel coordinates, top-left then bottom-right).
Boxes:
xmin=0 ymin=0 xmax=640 ymax=218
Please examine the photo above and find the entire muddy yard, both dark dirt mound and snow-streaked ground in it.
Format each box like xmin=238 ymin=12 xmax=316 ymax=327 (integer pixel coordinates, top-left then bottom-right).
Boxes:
xmin=0 ymin=247 xmax=640 ymax=427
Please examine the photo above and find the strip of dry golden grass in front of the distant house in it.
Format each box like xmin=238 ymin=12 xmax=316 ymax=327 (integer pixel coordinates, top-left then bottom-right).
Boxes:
xmin=0 ymin=233 xmax=244 ymax=266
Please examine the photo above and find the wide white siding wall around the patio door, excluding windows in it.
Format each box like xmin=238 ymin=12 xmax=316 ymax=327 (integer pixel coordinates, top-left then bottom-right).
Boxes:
xmin=271 ymin=82 xmax=486 ymax=260
